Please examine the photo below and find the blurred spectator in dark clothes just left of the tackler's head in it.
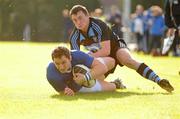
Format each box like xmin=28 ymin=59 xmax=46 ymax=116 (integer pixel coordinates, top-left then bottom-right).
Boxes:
xmin=61 ymin=9 xmax=73 ymax=42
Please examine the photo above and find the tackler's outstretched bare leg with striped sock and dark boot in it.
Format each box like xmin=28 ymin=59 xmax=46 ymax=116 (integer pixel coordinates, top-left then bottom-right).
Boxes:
xmin=116 ymin=48 xmax=174 ymax=92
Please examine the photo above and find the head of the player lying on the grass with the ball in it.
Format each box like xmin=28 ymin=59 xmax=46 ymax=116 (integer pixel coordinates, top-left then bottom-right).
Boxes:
xmin=51 ymin=46 xmax=71 ymax=73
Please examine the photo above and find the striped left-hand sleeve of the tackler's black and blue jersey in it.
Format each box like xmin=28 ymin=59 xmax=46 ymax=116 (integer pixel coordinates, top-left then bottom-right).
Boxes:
xmin=69 ymin=28 xmax=80 ymax=50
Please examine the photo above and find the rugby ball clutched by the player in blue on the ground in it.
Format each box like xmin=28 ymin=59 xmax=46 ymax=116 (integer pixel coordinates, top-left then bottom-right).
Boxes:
xmin=73 ymin=64 xmax=96 ymax=88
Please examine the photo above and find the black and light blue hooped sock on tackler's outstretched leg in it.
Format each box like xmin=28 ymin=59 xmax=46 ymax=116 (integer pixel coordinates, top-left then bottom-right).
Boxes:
xmin=137 ymin=63 xmax=161 ymax=83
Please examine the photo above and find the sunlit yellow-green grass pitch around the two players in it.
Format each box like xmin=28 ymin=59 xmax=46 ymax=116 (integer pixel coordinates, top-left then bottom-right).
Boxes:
xmin=0 ymin=42 xmax=180 ymax=119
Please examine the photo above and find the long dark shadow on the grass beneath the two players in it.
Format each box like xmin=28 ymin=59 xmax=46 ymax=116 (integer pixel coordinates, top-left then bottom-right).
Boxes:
xmin=51 ymin=91 xmax=171 ymax=101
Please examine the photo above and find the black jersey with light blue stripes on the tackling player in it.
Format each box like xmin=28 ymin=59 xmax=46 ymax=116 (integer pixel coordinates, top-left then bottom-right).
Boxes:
xmin=70 ymin=17 xmax=112 ymax=51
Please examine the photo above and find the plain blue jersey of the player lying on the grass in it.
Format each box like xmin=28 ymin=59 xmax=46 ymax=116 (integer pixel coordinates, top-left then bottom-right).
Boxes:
xmin=46 ymin=50 xmax=94 ymax=92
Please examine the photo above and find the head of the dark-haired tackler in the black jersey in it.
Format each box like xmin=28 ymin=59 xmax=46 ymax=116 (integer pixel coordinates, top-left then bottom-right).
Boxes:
xmin=70 ymin=5 xmax=89 ymax=30
